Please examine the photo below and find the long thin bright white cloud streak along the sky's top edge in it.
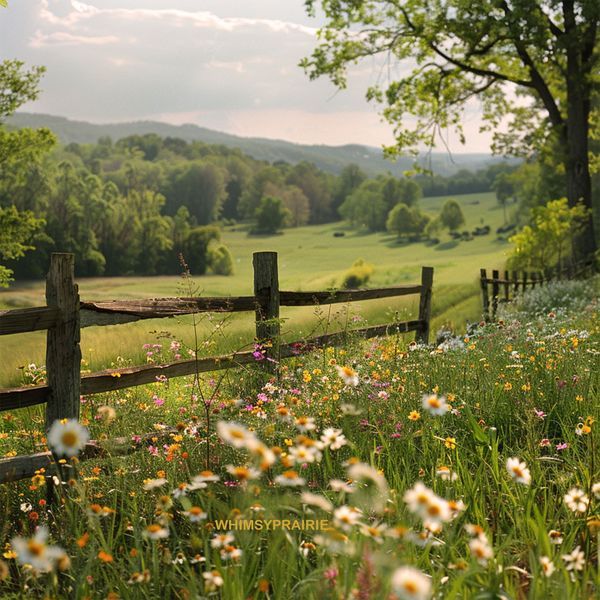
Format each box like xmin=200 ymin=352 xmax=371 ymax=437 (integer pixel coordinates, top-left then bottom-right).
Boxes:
xmin=40 ymin=0 xmax=317 ymax=37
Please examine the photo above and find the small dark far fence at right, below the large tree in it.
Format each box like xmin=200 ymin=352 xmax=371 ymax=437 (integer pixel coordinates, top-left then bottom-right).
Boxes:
xmin=480 ymin=261 xmax=595 ymax=322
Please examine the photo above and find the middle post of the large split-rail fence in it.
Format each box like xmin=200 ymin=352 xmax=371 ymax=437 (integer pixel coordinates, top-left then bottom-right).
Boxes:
xmin=252 ymin=252 xmax=280 ymax=371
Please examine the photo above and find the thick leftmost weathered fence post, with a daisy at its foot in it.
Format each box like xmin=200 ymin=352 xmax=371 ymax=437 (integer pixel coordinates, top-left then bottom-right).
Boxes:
xmin=46 ymin=253 xmax=81 ymax=429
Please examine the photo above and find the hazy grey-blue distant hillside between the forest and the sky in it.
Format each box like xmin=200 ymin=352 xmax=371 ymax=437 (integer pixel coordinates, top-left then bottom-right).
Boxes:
xmin=7 ymin=113 xmax=510 ymax=176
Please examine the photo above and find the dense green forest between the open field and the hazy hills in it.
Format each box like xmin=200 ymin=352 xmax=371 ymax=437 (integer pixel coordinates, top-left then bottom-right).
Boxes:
xmin=0 ymin=126 xmax=548 ymax=279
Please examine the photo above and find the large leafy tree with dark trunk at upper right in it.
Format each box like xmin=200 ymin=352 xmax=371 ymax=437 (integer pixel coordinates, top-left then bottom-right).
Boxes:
xmin=302 ymin=0 xmax=600 ymax=256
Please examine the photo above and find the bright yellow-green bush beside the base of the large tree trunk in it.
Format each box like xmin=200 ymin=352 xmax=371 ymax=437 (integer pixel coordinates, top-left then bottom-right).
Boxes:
xmin=508 ymin=198 xmax=588 ymax=270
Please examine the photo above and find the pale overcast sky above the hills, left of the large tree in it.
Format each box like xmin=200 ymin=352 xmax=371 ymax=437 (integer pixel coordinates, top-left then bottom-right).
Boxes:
xmin=0 ymin=0 xmax=490 ymax=152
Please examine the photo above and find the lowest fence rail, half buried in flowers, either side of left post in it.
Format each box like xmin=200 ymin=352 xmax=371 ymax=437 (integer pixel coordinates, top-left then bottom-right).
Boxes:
xmin=0 ymin=427 xmax=177 ymax=484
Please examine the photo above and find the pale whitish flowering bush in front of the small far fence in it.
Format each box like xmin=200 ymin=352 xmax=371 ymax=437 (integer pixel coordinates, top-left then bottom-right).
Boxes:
xmin=499 ymin=276 xmax=600 ymax=318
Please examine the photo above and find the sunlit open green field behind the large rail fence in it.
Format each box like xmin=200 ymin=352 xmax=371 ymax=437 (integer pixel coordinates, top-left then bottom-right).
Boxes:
xmin=0 ymin=193 xmax=508 ymax=386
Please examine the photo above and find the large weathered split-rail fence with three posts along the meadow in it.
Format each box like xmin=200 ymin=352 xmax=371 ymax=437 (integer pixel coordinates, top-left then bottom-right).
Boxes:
xmin=0 ymin=252 xmax=433 ymax=483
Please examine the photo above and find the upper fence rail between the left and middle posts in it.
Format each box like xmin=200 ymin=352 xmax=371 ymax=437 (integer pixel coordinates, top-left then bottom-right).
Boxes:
xmin=81 ymin=296 xmax=256 ymax=327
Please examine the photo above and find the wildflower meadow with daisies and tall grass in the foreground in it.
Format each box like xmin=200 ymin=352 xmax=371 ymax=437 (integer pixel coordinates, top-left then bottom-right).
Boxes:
xmin=0 ymin=284 xmax=600 ymax=600
